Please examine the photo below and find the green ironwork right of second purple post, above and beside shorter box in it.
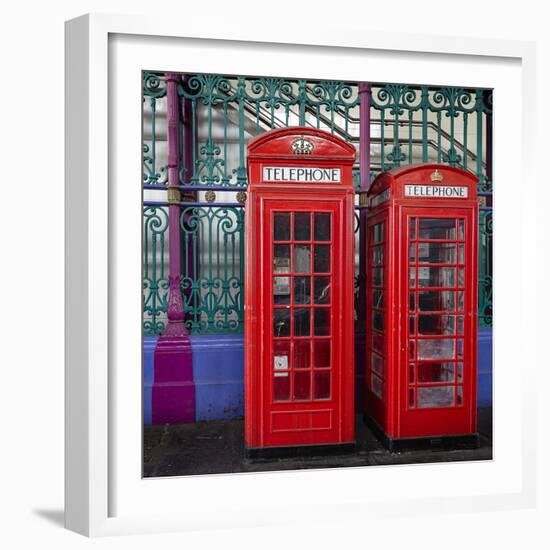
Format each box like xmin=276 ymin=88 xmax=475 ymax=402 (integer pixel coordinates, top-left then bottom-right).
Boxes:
xmin=371 ymin=84 xmax=493 ymax=327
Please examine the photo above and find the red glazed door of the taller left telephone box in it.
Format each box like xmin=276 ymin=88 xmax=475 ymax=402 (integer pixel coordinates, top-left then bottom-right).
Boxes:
xmin=262 ymin=201 xmax=350 ymax=446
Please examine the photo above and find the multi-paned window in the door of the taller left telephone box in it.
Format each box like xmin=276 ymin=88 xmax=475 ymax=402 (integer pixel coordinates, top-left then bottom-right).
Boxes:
xmin=271 ymin=211 xmax=334 ymax=402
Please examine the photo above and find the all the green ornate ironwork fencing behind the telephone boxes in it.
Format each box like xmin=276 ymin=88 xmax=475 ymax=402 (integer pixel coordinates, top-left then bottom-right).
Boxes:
xmin=143 ymin=72 xmax=492 ymax=334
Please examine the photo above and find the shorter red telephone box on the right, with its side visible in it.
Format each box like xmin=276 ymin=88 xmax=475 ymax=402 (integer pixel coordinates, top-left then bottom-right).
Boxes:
xmin=366 ymin=164 xmax=484 ymax=450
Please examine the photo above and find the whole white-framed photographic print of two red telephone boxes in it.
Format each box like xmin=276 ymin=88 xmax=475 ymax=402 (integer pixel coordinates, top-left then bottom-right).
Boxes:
xmin=66 ymin=11 xmax=534 ymax=535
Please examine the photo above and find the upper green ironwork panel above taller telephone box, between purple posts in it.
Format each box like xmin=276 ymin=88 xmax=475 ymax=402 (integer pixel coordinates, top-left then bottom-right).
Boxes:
xmin=178 ymin=75 xmax=359 ymax=187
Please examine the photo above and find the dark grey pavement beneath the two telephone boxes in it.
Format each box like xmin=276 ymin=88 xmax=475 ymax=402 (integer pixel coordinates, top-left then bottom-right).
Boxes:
xmin=143 ymin=408 xmax=493 ymax=477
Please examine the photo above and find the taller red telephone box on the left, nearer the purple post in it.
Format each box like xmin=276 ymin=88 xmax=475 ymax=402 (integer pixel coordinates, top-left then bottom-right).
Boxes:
xmin=245 ymin=127 xmax=355 ymax=457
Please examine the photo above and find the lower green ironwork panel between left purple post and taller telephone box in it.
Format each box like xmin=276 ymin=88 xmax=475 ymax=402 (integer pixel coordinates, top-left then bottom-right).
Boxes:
xmin=180 ymin=206 xmax=244 ymax=334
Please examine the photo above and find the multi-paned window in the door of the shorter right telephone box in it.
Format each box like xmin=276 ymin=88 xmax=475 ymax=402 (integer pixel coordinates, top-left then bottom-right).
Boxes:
xmin=407 ymin=217 xmax=466 ymax=409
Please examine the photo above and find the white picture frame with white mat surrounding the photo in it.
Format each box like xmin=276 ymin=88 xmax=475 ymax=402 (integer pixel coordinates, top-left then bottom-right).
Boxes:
xmin=65 ymin=15 xmax=541 ymax=536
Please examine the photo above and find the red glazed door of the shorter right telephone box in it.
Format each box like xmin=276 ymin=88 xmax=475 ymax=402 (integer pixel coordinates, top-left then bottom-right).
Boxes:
xmin=400 ymin=207 xmax=477 ymax=437
